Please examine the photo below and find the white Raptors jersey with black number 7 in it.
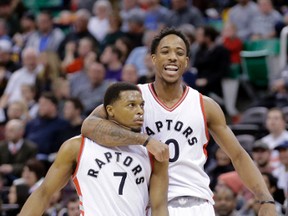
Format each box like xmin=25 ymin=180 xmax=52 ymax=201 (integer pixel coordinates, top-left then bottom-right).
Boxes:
xmin=73 ymin=138 xmax=151 ymax=216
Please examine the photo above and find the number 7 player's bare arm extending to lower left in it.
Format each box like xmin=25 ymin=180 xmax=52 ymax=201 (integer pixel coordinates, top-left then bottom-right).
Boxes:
xmin=20 ymin=137 xmax=81 ymax=216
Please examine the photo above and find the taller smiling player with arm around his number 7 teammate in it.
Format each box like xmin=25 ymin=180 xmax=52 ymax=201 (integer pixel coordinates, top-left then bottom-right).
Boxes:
xmin=82 ymin=29 xmax=276 ymax=216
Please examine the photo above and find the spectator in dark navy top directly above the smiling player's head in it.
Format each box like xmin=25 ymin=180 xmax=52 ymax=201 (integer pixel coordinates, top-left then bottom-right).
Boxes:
xmin=166 ymin=0 xmax=204 ymax=28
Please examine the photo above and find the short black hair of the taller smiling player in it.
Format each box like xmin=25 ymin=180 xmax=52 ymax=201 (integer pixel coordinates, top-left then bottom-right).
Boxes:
xmin=150 ymin=28 xmax=190 ymax=56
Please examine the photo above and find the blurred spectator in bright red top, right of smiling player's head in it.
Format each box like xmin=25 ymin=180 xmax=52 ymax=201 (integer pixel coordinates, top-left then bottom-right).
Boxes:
xmin=222 ymin=22 xmax=243 ymax=65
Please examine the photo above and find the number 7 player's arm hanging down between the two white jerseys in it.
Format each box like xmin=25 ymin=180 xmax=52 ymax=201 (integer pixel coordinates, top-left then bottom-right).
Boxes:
xmin=150 ymin=159 xmax=169 ymax=216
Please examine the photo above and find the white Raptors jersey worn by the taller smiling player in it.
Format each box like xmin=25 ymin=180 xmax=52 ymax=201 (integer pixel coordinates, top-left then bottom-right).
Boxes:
xmin=138 ymin=83 xmax=214 ymax=204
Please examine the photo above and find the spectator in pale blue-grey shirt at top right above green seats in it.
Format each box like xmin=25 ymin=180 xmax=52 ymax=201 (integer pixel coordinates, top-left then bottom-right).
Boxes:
xmin=250 ymin=0 xmax=282 ymax=40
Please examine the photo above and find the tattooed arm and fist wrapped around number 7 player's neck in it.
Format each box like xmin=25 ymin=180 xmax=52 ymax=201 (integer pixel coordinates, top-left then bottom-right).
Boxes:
xmin=81 ymin=105 xmax=169 ymax=161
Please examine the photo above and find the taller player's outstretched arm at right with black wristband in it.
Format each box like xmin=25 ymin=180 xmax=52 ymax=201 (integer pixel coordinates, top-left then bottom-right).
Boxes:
xmin=204 ymin=97 xmax=276 ymax=216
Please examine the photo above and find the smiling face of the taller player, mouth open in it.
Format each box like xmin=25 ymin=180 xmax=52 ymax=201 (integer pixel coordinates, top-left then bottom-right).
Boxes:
xmin=152 ymin=34 xmax=189 ymax=84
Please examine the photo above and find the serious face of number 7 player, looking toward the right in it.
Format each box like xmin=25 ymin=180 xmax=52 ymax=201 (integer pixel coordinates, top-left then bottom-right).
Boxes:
xmin=107 ymin=90 xmax=144 ymax=132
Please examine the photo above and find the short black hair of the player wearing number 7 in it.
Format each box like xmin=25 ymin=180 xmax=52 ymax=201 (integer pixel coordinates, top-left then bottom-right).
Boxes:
xmin=104 ymin=82 xmax=141 ymax=110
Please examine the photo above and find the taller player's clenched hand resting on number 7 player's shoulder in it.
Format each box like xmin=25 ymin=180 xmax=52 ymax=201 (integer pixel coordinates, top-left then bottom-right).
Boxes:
xmin=146 ymin=138 xmax=169 ymax=162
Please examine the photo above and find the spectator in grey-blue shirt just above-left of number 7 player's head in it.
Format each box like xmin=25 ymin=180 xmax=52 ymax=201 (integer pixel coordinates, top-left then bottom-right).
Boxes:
xmin=72 ymin=62 xmax=111 ymax=115
